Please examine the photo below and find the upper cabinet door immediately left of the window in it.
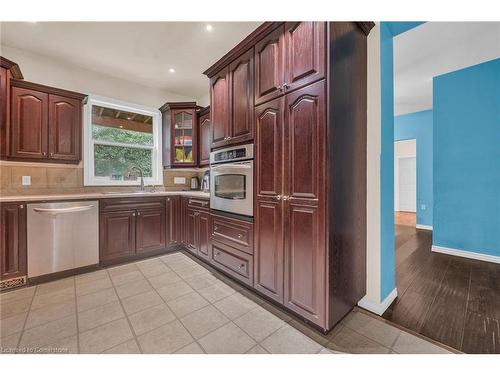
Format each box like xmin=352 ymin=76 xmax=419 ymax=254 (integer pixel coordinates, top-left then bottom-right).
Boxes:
xmin=49 ymin=95 xmax=82 ymax=162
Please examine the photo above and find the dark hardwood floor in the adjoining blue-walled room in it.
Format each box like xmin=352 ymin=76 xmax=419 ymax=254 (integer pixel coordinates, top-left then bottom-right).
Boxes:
xmin=383 ymin=225 xmax=500 ymax=353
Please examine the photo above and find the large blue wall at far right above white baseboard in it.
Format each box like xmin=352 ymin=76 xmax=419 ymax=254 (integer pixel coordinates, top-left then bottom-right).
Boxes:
xmin=433 ymin=59 xmax=500 ymax=256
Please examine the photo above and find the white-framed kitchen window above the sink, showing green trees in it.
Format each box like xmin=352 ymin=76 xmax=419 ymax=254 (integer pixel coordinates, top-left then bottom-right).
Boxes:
xmin=84 ymin=96 xmax=163 ymax=186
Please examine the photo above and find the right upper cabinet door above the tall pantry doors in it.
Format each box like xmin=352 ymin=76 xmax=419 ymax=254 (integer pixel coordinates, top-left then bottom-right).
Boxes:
xmin=285 ymin=22 xmax=326 ymax=92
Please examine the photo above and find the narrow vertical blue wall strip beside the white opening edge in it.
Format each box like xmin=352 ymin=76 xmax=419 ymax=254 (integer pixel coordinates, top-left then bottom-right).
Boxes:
xmin=380 ymin=22 xmax=396 ymax=301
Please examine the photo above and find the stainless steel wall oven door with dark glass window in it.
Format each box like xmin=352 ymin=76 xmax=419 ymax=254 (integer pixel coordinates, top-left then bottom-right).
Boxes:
xmin=210 ymin=160 xmax=253 ymax=216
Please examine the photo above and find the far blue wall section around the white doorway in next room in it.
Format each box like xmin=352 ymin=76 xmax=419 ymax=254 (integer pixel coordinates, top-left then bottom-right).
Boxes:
xmin=394 ymin=110 xmax=433 ymax=226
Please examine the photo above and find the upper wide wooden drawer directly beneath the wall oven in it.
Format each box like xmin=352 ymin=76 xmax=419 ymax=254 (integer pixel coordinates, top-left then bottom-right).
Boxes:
xmin=210 ymin=215 xmax=253 ymax=255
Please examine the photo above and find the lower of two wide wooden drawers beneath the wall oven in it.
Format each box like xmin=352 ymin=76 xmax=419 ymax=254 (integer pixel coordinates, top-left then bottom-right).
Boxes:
xmin=210 ymin=241 xmax=253 ymax=286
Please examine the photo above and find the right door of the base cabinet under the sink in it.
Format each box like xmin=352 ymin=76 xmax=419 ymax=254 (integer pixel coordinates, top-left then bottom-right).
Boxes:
xmin=136 ymin=208 xmax=165 ymax=253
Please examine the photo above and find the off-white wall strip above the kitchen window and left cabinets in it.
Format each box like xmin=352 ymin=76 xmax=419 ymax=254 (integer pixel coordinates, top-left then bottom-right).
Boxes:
xmin=0 ymin=46 xmax=194 ymax=108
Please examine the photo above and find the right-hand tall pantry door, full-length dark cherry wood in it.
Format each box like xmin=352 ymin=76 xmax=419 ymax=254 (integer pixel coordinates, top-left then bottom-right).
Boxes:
xmin=284 ymin=81 xmax=327 ymax=327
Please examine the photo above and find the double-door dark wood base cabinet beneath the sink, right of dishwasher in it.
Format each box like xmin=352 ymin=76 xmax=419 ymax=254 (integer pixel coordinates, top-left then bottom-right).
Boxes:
xmin=99 ymin=197 xmax=167 ymax=264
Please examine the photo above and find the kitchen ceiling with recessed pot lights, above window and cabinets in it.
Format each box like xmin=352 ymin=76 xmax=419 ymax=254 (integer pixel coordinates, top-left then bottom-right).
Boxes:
xmin=0 ymin=22 xmax=260 ymax=100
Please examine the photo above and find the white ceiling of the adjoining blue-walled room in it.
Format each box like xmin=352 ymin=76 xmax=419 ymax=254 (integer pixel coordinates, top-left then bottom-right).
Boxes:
xmin=394 ymin=22 xmax=500 ymax=115
